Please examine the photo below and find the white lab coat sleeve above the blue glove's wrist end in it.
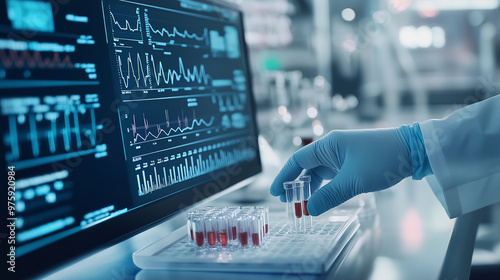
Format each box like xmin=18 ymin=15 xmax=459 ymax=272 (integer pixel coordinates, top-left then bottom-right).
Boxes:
xmin=420 ymin=96 xmax=500 ymax=218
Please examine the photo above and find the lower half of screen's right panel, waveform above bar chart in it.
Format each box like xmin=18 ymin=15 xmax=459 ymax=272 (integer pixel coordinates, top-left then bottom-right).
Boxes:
xmin=121 ymin=93 xmax=255 ymax=196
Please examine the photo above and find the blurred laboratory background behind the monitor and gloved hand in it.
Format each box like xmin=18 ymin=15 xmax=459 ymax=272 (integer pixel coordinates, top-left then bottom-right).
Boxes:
xmin=226 ymin=0 xmax=500 ymax=280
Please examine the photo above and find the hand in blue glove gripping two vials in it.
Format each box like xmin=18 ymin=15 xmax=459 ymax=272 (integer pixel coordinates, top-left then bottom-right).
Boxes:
xmin=271 ymin=123 xmax=432 ymax=216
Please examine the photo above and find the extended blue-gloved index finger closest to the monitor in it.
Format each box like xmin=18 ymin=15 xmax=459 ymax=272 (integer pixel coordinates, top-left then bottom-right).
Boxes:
xmin=271 ymin=143 xmax=320 ymax=196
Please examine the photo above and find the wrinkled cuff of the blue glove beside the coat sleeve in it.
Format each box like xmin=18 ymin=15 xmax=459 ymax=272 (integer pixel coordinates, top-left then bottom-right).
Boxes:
xmin=399 ymin=122 xmax=433 ymax=180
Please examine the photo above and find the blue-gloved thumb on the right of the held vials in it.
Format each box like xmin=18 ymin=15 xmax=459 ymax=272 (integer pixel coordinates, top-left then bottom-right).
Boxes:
xmin=307 ymin=170 xmax=356 ymax=216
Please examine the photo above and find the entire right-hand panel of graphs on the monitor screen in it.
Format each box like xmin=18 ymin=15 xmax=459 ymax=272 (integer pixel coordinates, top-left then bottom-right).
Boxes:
xmin=105 ymin=0 xmax=256 ymax=201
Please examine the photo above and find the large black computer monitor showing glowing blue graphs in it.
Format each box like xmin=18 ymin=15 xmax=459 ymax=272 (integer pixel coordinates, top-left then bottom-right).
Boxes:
xmin=0 ymin=0 xmax=261 ymax=277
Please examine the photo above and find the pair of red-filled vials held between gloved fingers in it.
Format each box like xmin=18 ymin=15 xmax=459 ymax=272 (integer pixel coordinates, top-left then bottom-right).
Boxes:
xmin=283 ymin=175 xmax=313 ymax=232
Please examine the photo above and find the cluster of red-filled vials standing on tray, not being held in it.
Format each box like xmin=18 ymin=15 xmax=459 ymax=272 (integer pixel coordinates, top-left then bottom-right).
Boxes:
xmin=186 ymin=206 xmax=269 ymax=249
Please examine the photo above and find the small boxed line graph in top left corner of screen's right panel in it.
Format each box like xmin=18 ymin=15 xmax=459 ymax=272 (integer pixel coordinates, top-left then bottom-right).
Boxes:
xmin=109 ymin=6 xmax=143 ymax=42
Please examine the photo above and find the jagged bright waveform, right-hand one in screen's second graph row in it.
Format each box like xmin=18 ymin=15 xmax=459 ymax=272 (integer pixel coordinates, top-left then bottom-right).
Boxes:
xmin=151 ymin=55 xmax=211 ymax=86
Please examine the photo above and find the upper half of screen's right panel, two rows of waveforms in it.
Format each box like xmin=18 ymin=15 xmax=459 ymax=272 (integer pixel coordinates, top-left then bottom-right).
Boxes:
xmin=108 ymin=1 xmax=245 ymax=95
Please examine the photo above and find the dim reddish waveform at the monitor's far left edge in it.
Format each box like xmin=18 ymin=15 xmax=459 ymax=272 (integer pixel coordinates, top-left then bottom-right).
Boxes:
xmin=0 ymin=50 xmax=74 ymax=69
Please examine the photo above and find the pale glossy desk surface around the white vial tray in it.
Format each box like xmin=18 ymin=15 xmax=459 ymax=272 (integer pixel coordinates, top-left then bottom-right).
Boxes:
xmin=42 ymin=174 xmax=454 ymax=280
